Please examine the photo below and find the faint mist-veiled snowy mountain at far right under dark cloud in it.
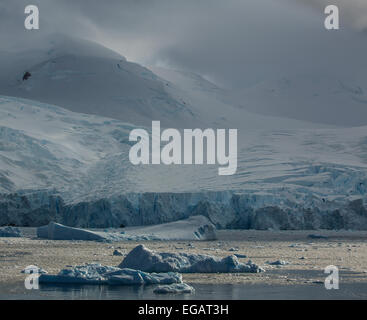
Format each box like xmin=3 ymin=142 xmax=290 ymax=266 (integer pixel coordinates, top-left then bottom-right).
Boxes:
xmin=237 ymin=71 xmax=367 ymax=126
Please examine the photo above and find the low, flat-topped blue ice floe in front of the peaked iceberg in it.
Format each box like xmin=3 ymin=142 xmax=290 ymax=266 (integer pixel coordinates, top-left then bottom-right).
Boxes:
xmin=39 ymin=264 xmax=182 ymax=285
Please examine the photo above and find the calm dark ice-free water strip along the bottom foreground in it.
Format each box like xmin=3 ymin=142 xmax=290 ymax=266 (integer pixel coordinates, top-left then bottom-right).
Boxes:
xmin=0 ymin=283 xmax=367 ymax=300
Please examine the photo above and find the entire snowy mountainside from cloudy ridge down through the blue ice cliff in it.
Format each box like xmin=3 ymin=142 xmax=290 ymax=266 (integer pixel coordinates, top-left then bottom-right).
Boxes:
xmin=0 ymin=38 xmax=367 ymax=229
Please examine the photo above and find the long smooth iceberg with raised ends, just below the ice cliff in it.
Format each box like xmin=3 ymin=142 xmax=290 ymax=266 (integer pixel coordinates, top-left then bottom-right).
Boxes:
xmin=37 ymin=216 xmax=216 ymax=241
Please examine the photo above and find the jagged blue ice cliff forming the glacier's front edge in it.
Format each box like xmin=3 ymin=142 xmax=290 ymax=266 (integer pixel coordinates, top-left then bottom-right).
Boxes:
xmin=0 ymin=191 xmax=367 ymax=230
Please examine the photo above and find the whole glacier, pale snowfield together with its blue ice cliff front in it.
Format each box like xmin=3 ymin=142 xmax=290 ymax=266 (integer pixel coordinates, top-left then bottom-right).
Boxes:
xmin=0 ymin=97 xmax=367 ymax=229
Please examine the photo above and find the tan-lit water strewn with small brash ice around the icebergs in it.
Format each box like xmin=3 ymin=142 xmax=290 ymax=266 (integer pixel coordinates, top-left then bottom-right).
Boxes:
xmin=0 ymin=228 xmax=367 ymax=293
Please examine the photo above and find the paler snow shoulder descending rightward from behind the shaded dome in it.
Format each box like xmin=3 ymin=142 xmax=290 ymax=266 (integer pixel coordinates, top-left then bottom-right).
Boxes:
xmin=149 ymin=66 xmax=325 ymax=132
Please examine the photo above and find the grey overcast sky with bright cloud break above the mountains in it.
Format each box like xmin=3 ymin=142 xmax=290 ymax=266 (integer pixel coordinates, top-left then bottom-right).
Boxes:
xmin=0 ymin=0 xmax=367 ymax=89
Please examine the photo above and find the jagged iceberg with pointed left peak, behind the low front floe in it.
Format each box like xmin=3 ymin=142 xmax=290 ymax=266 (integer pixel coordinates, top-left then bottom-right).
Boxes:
xmin=119 ymin=245 xmax=264 ymax=273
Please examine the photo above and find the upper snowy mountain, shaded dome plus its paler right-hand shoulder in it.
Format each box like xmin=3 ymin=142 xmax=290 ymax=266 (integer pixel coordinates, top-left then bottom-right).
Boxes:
xmin=0 ymin=35 xmax=322 ymax=129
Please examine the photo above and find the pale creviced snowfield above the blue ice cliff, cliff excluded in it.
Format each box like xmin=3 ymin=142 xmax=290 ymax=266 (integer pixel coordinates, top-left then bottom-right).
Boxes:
xmin=0 ymin=97 xmax=367 ymax=201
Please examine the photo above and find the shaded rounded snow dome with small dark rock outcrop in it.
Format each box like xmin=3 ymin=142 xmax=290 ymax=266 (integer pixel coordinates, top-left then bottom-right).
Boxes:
xmin=0 ymin=35 xmax=197 ymax=126
